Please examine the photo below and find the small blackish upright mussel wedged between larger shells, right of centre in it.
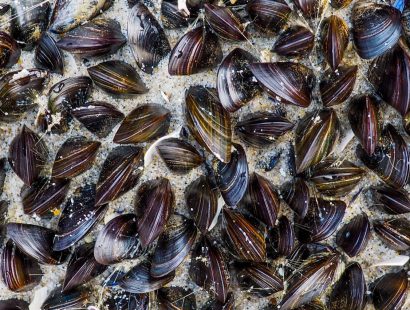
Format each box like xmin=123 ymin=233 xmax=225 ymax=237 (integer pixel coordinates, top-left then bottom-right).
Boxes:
xmin=281 ymin=178 xmax=310 ymax=218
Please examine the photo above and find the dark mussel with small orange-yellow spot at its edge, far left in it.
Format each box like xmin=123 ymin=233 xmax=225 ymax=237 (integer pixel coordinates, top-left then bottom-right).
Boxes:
xmin=20 ymin=177 xmax=70 ymax=216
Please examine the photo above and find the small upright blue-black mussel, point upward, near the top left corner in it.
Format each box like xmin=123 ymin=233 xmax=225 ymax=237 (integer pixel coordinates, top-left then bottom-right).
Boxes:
xmin=34 ymin=32 xmax=64 ymax=74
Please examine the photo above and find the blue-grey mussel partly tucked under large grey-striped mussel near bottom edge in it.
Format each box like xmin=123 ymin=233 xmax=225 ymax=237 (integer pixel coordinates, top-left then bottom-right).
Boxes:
xmin=119 ymin=261 xmax=175 ymax=294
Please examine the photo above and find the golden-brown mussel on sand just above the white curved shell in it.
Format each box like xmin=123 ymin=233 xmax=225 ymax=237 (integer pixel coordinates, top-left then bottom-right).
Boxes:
xmin=114 ymin=104 xmax=171 ymax=144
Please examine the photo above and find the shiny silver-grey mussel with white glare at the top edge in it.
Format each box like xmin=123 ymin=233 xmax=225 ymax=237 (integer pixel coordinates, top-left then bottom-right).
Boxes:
xmin=128 ymin=2 xmax=171 ymax=74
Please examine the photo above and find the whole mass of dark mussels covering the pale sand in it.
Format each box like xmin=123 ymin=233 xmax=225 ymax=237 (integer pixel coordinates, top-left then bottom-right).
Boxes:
xmin=0 ymin=0 xmax=410 ymax=310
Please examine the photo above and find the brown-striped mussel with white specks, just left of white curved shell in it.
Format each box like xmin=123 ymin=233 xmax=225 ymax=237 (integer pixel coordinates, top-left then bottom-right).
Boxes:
xmin=95 ymin=145 xmax=144 ymax=205
